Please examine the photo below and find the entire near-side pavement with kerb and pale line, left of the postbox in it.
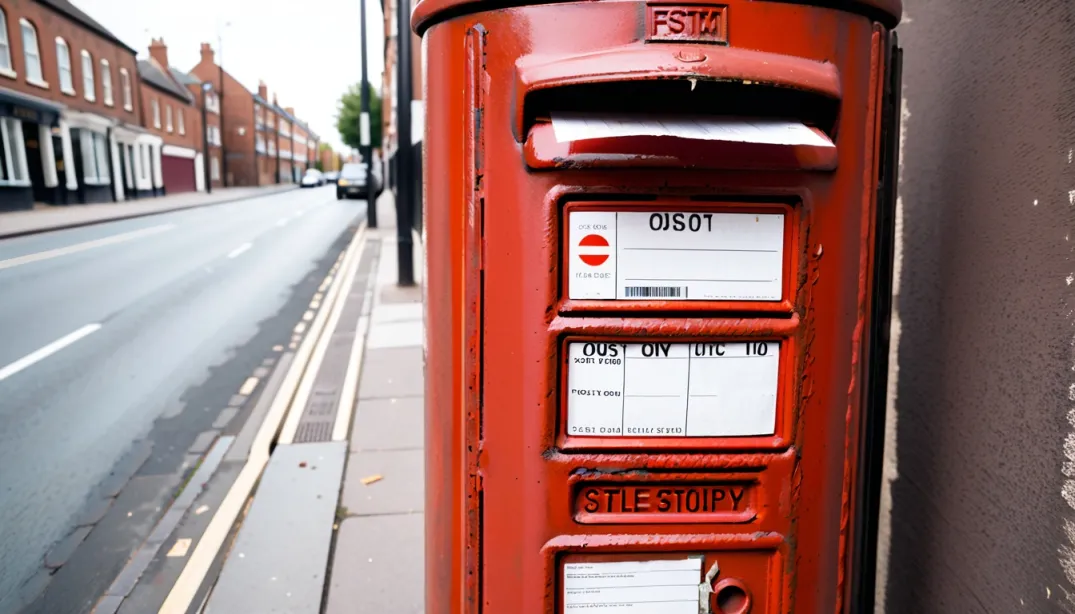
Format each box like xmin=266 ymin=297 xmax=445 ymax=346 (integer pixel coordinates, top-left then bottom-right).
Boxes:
xmin=150 ymin=192 xmax=425 ymax=614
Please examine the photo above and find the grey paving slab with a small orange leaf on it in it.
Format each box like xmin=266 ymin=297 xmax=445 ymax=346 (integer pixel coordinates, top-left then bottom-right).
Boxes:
xmin=341 ymin=449 xmax=426 ymax=516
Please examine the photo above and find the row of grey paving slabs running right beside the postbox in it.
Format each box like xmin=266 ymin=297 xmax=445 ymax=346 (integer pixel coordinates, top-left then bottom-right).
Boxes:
xmin=325 ymin=193 xmax=425 ymax=614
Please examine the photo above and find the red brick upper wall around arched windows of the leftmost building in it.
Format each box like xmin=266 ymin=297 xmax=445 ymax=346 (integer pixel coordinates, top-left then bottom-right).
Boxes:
xmin=0 ymin=0 xmax=141 ymax=126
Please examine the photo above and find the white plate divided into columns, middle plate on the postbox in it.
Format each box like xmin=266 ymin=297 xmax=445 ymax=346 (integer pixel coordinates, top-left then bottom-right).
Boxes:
xmin=568 ymin=341 xmax=780 ymax=438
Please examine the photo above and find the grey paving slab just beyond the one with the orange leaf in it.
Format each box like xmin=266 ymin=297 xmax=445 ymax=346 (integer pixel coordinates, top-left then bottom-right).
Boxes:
xmin=350 ymin=397 xmax=426 ymax=452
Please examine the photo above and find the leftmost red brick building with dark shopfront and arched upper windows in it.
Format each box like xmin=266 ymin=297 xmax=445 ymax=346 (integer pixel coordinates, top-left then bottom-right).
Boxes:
xmin=0 ymin=0 xmax=161 ymax=210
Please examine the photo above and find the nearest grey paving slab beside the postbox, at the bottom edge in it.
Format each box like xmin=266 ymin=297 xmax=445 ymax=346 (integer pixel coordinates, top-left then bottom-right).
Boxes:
xmin=326 ymin=514 xmax=426 ymax=614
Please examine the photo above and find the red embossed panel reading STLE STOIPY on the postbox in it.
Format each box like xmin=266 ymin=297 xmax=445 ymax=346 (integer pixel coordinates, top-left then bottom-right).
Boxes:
xmin=575 ymin=482 xmax=757 ymax=525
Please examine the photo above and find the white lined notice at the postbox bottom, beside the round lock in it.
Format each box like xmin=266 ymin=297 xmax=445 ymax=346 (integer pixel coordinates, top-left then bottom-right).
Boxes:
xmin=563 ymin=557 xmax=702 ymax=614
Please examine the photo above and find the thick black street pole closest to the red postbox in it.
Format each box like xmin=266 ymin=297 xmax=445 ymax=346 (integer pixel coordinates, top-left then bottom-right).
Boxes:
xmin=396 ymin=0 xmax=416 ymax=286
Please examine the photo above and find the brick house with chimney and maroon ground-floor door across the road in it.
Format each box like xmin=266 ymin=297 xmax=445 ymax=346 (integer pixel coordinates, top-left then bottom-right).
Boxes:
xmin=138 ymin=39 xmax=205 ymax=194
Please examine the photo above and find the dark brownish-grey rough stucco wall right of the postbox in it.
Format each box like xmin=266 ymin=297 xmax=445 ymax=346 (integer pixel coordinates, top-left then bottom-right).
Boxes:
xmin=879 ymin=0 xmax=1075 ymax=614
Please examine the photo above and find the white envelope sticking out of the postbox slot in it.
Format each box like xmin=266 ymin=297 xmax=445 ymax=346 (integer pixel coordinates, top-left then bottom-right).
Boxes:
xmin=550 ymin=112 xmax=835 ymax=147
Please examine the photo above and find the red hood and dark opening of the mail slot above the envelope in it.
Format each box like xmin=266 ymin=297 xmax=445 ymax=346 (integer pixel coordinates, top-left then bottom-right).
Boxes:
xmin=515 ymin=44 xmax=841 ymax=142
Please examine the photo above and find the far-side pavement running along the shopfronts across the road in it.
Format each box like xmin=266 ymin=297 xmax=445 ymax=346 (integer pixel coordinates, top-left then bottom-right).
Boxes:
xmin=0 ymin=184 xmax=297 ymax=239
